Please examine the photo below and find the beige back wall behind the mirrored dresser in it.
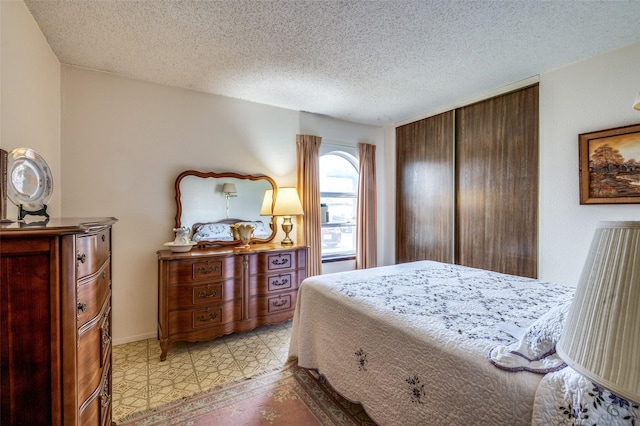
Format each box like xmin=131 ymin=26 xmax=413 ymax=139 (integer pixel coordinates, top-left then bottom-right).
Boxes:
xmin=62 ymin=66 xmax=383 ymax=344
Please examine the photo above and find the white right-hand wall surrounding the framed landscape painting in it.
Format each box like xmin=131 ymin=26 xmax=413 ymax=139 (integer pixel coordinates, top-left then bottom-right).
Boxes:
xmin=539 ymin=43 xmax=640 ymax=285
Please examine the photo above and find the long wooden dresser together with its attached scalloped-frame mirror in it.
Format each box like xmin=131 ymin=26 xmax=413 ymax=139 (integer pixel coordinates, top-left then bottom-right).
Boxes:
xmin=157 ymin=170 xmax=307 ymax=361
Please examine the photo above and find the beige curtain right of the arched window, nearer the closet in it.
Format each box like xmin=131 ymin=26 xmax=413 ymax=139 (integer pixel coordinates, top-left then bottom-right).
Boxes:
xmin=356 ymin=143 xmax=378 ymax=269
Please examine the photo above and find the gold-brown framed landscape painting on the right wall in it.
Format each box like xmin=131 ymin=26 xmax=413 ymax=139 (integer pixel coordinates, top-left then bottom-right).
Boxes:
xmin=578 ymin=124 xmax=640 ymax=204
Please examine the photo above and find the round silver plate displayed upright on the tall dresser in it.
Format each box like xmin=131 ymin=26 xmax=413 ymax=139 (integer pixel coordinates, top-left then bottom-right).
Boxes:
xmin=7 ymin=148 xmax=53 ymax=211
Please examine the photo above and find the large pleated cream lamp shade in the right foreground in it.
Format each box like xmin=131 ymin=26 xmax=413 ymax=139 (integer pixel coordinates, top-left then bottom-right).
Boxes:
xmin=556 ymin=222 xmax=640 ymax=403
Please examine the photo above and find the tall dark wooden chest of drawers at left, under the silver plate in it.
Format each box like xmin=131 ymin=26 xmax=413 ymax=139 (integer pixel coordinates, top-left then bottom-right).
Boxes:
xmin=0 ymin=218 xmax=116 ymax=425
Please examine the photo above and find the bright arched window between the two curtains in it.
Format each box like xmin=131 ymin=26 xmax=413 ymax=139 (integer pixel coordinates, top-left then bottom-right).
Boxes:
xmin=320 ymin=151 xmax=358 ymax=261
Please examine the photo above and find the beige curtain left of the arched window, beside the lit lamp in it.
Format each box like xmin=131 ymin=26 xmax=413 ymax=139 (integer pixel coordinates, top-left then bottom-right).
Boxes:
xmin=296 ymin=135 xmax=322 ymax=277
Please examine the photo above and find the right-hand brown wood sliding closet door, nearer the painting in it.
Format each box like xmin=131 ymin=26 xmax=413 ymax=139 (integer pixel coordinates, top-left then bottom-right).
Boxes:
xmin=455 ymin=85 xmax=538 ymax=278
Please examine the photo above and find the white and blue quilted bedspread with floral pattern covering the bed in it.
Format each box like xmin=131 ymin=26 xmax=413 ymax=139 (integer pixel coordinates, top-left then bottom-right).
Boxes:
xmin=289 ymin=261 xmax=574 ymax=426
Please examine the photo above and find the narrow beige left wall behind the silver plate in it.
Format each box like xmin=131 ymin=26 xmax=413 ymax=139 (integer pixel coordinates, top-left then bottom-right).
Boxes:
xmin=0 ymin=1 xmax=62 ymax=219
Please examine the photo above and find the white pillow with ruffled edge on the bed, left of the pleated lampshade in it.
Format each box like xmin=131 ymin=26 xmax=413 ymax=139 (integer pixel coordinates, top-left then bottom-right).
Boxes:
xmin=489 ymin=300 xmax=571 ymax=374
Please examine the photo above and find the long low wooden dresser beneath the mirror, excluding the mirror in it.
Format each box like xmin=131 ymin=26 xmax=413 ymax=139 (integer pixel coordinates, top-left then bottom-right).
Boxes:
xmin=158 ymin=244 xmax=307 ymax=361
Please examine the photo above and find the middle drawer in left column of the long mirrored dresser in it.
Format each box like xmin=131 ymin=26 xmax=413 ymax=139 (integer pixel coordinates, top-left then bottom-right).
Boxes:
xmin=168 ymin=279 xmax=242 ymax=310
